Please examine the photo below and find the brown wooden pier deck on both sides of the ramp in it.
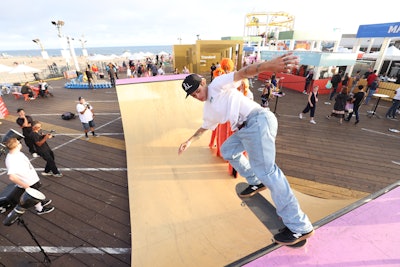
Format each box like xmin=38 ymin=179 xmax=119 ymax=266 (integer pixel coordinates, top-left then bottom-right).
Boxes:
xmin=0 ymin=76 xmax=400 ymax=266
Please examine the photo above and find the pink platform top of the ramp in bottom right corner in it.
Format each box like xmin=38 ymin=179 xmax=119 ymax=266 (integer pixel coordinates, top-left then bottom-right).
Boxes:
xmin=244 ymin=187 xmax=400 ymax=267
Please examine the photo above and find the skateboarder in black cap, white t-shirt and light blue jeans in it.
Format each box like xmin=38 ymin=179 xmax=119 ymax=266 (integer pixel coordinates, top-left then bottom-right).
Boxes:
xmin=178 ymin=53 xmax=314 ymax=245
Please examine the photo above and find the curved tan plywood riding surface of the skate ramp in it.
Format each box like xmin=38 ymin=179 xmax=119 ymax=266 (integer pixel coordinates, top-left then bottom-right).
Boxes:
xmin=117 ymin=79 xmax=351 ymax=267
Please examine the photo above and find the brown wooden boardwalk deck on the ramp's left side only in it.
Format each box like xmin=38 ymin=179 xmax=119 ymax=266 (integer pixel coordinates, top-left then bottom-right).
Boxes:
xmin=0 ymin=80 xmax=131 ymax=266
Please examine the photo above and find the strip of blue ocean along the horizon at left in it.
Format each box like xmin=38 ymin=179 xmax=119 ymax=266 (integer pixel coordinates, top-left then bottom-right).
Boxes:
xmin=0 ymin=45 xmax=172 ymax=58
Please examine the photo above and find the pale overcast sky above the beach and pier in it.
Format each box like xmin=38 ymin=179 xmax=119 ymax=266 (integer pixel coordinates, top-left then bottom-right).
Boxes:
xmin=0 ymin=0 xmax=400 ymax=52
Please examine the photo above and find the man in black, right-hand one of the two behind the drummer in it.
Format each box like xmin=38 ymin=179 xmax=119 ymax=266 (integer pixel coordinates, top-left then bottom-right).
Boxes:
xmin=31 ymin=121 xmax=63 ymax=177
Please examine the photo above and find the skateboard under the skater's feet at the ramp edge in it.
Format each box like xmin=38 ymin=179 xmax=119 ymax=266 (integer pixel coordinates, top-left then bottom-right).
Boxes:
xmin=236 ymin=183 xmax=307 ymax=248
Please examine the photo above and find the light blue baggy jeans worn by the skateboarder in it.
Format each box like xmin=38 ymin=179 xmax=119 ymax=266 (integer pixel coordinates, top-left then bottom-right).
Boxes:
xmin=221 ymin=108 xmax=313 ymax=233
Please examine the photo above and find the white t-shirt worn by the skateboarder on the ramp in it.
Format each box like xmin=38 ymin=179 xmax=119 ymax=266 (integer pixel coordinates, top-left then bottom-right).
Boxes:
xmin=202 ymin=72 xmax=260 ymax=131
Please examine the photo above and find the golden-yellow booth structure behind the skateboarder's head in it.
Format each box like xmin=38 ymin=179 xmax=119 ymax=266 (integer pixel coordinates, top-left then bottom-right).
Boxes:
xmin=173 ymin=37 xmax=243 ymax=74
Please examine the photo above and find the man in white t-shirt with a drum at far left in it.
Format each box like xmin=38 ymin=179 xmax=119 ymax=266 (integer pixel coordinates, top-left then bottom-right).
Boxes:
xmin=5 ymin=138 xmax=54 ymax=215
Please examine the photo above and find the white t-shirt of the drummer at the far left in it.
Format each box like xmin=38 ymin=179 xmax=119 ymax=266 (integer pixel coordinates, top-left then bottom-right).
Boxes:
xmin=5 ymin=152 xmax=39 ymax=186
